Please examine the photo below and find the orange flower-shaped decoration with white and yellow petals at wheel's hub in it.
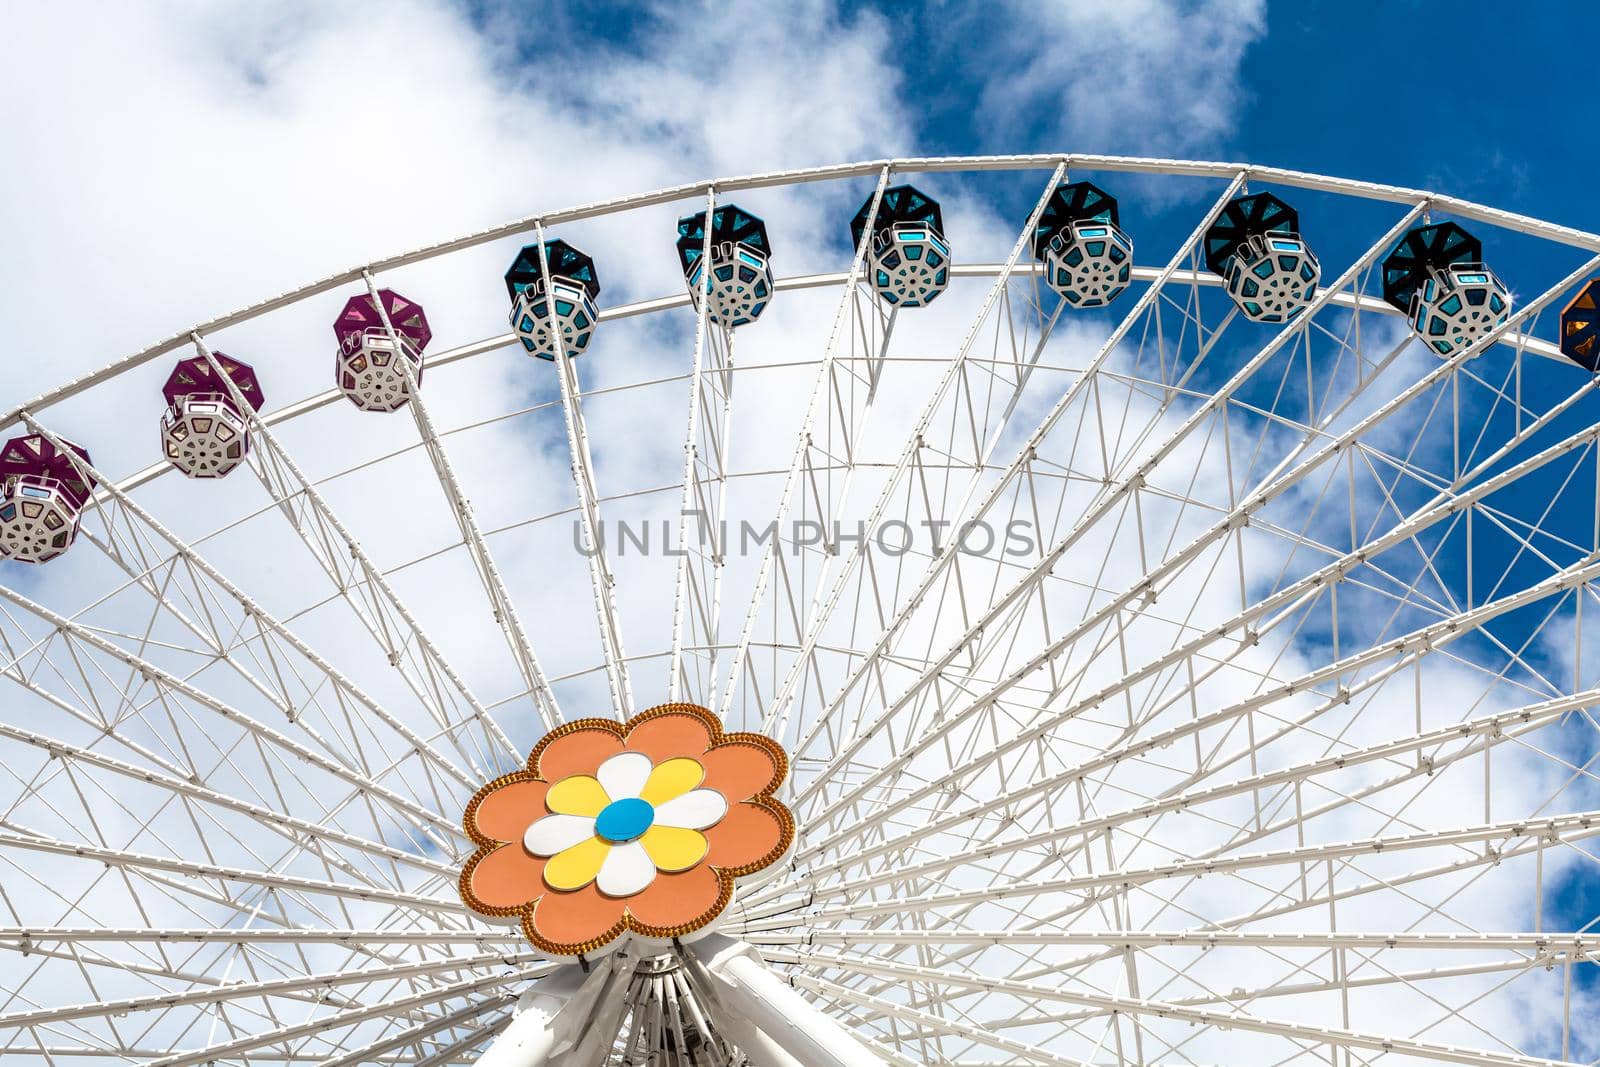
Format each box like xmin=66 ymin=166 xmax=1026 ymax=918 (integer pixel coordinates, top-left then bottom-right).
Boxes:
xmin=461 ymin=704 xmax=794 ymax=957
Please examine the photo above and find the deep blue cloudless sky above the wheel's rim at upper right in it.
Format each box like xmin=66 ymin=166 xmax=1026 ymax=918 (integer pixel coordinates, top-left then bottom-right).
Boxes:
xmin=883 ymin=0 xmax=1580 ymax=220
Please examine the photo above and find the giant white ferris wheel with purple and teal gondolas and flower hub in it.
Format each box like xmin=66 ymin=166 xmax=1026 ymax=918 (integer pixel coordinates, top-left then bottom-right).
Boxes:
xmin=0 ymin=155 xmax=1600 ymax=1067
